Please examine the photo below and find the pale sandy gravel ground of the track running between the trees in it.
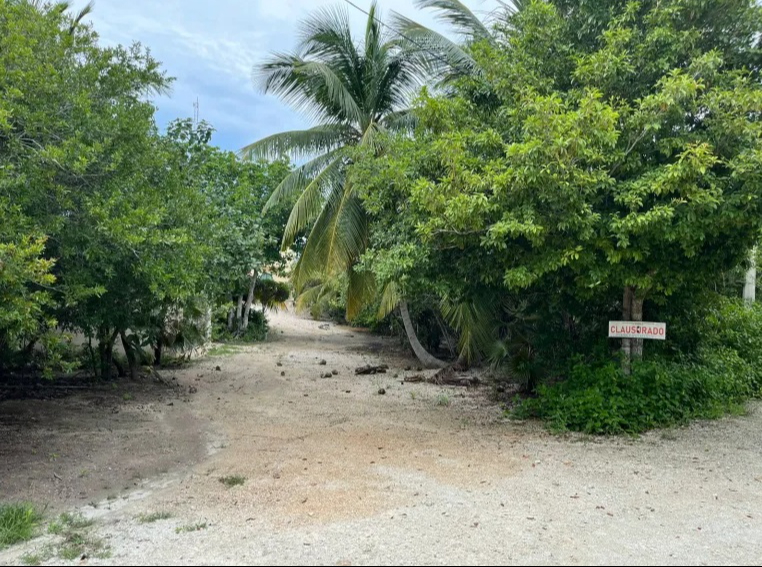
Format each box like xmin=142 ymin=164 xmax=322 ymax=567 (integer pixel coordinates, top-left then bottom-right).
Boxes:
xmin=0 ymin=313 xmax=762 ymax=565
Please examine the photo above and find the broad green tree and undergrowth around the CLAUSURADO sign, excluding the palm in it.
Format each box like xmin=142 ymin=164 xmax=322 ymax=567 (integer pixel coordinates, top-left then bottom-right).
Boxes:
xmin=351 ymin=0 xmax=762 ymax=431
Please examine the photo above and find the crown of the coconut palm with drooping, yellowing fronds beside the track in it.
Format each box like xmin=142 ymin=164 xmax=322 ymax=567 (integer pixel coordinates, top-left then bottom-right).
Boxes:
xmin=242 ymin=2 xmax=425 ymax=318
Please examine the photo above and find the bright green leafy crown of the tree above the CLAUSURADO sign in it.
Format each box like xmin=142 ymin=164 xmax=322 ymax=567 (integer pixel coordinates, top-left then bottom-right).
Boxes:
xmin=350 ymin=0 xmax=762 ymax=370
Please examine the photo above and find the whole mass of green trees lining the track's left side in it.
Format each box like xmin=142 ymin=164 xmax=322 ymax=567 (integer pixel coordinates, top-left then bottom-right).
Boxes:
xmin=0 ymin=0 xmax=289 ymax=377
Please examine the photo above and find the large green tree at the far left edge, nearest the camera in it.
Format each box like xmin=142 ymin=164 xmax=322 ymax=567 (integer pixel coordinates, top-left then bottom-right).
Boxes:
xmin=0 ymin=1 xmax=215 ymax=382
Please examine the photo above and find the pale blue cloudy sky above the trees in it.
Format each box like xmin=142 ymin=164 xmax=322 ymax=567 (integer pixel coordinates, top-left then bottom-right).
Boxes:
xmin=72 ymin=0 xmax=497 ymax=151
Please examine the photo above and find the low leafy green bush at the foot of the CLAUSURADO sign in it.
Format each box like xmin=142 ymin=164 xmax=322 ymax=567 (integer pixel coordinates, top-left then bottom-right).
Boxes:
xmin=515 ymin=299 xmax=762 ymax=434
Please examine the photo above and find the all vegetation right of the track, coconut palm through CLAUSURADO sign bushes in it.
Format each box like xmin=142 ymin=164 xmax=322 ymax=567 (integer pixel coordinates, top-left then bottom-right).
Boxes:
xmin=252 ymin=0 xmax=762 ymax=433
